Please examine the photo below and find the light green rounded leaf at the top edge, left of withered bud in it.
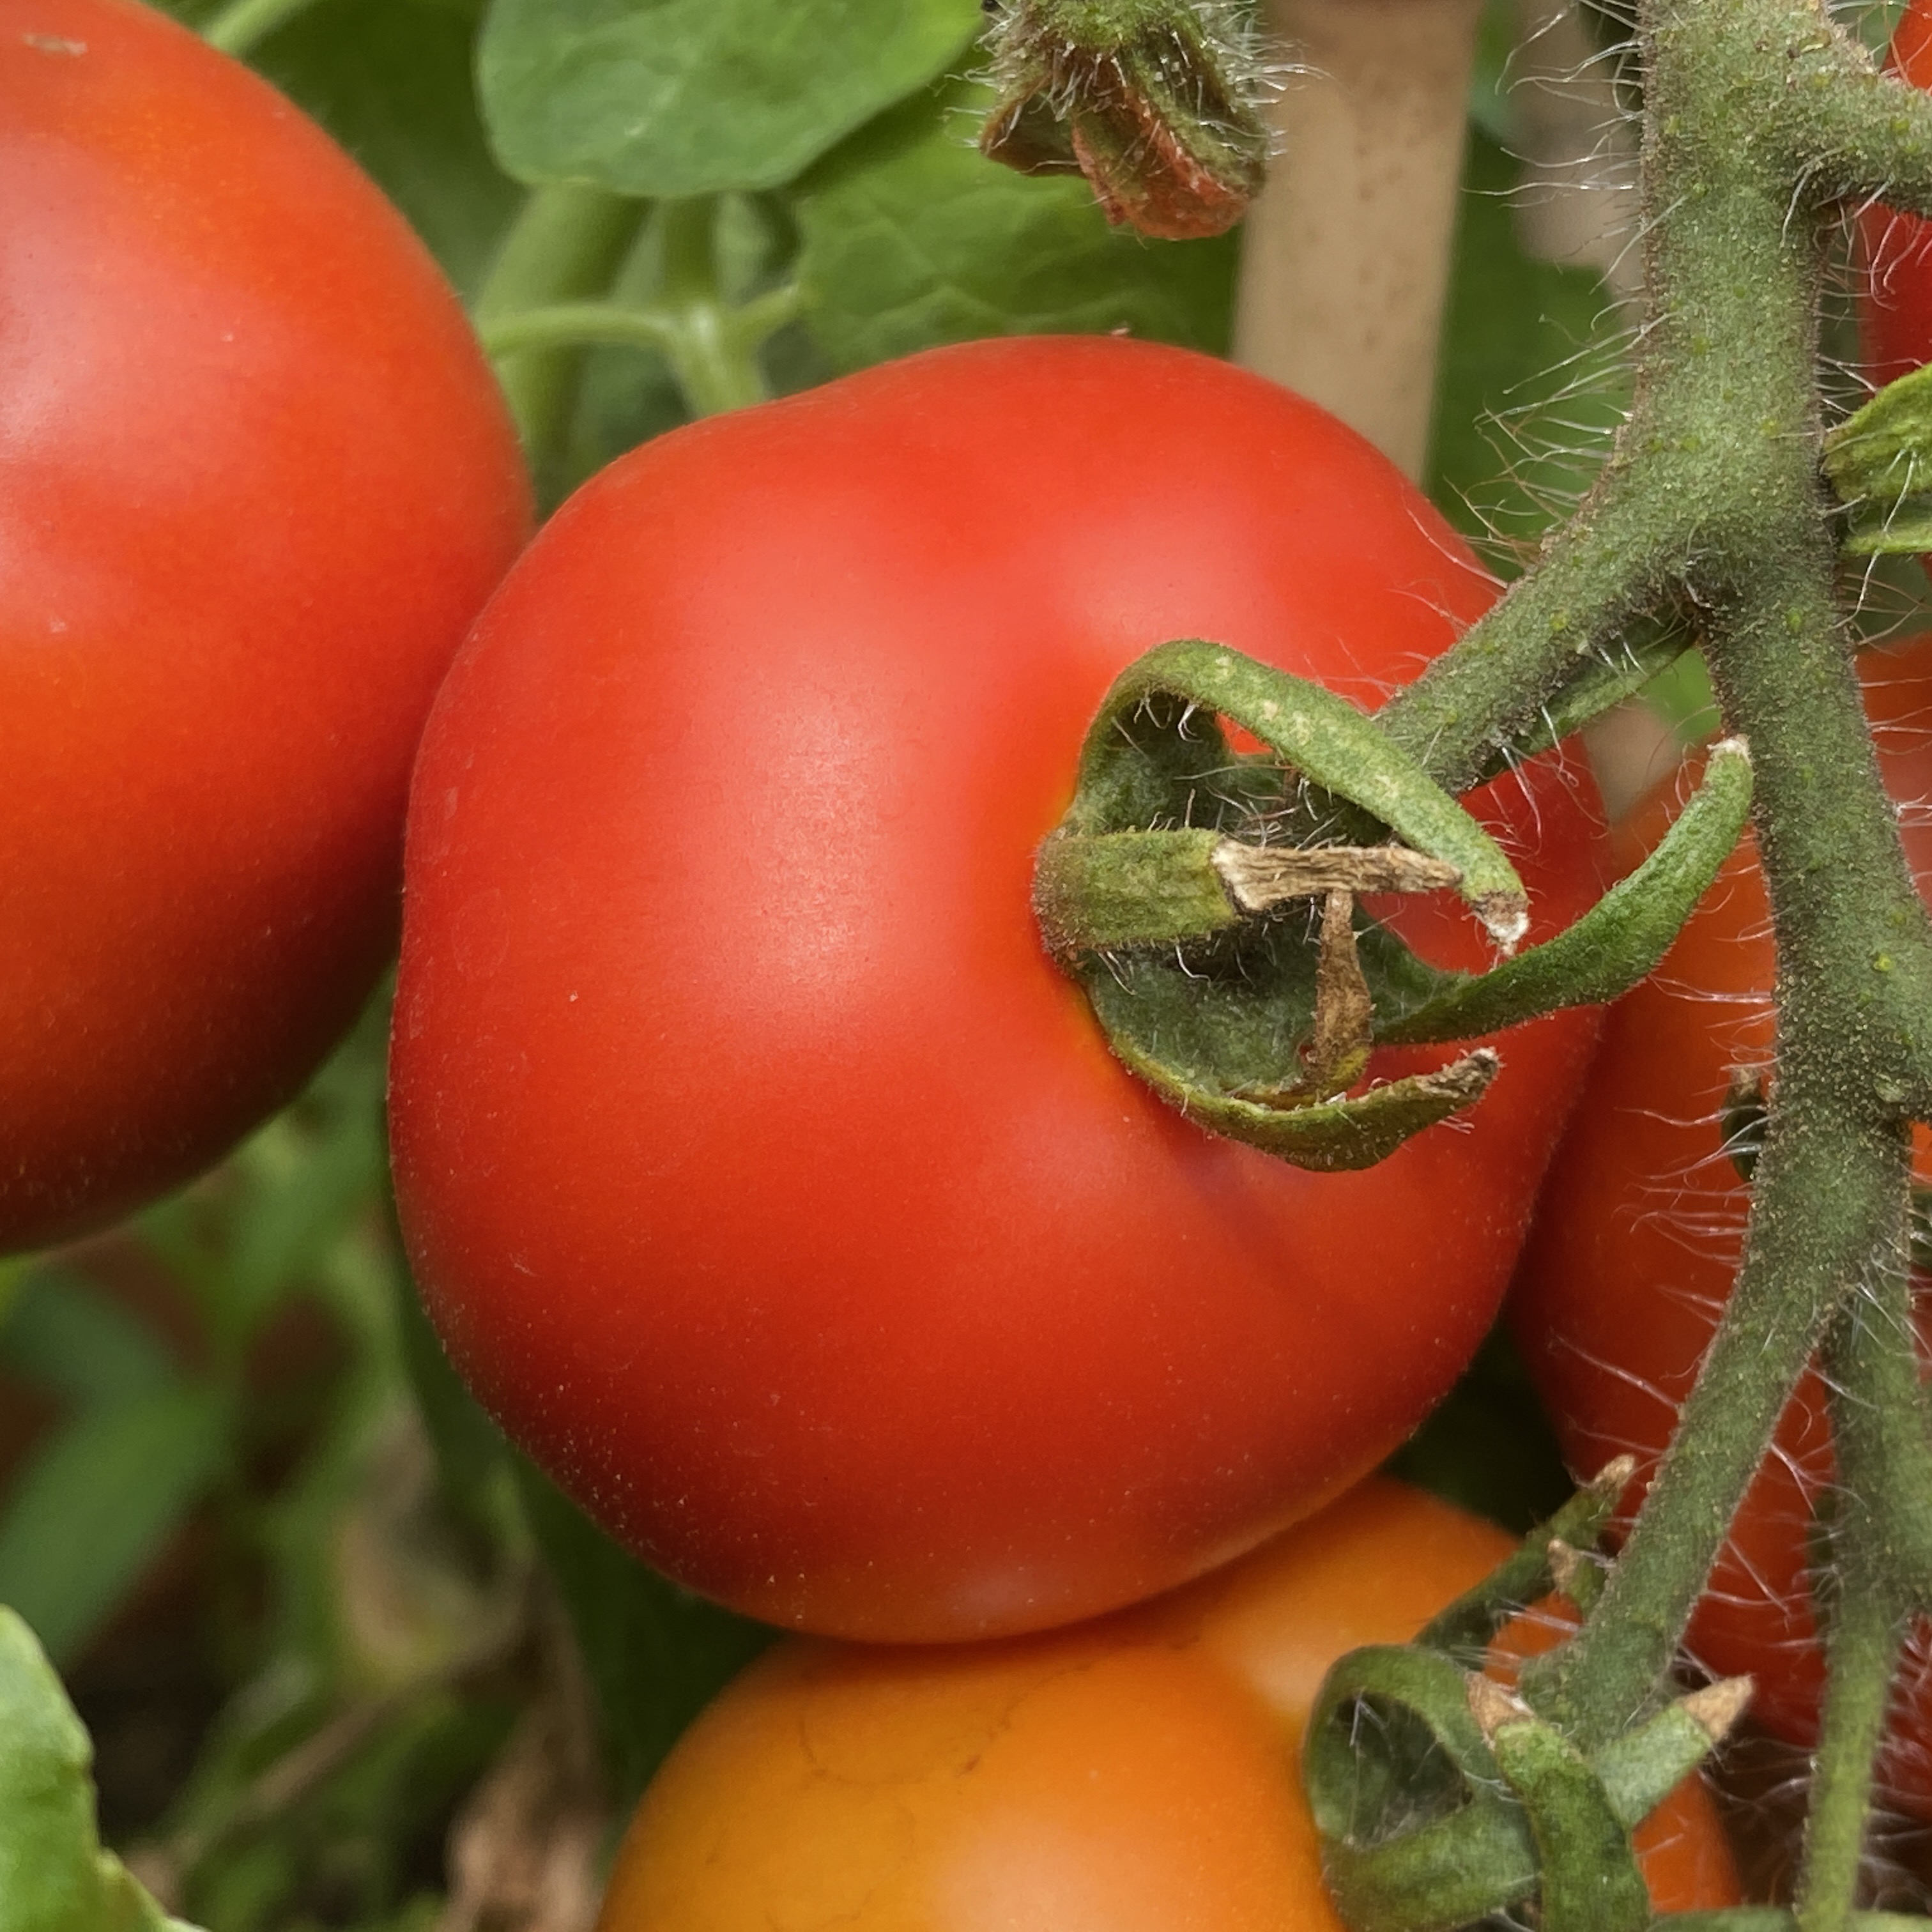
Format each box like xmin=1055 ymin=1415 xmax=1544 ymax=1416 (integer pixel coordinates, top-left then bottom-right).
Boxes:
xmin=479 ymin=0 xmax=979 ymax=197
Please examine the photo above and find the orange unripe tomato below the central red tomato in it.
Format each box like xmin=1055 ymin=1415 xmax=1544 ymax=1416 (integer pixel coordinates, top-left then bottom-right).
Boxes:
xmin=599 ymin=1482 xmax=1737 ymax=1932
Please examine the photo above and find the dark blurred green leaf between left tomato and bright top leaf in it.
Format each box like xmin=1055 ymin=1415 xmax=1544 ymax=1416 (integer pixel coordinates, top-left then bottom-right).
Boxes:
xmin=243 ymin=0 xmax=521 ymax=296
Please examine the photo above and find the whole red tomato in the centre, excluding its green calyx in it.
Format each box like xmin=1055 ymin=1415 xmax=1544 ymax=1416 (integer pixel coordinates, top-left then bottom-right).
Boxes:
xmin=392 ymin=338 xmax=1598 ymax=1640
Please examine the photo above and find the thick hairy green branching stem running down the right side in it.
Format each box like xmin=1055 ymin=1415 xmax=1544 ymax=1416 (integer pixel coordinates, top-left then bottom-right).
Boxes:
xmin=1381 ymin=0 xmax=1932 ymax=1885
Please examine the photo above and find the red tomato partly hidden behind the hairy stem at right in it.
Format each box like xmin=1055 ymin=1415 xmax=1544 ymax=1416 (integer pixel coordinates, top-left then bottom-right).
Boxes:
xmin=1511 ymin=636 xmax=1932 ymax=1810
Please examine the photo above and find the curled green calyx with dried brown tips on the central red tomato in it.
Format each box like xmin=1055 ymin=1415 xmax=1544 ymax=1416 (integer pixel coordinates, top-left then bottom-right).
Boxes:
xmin=1034 ymin=640 xmax=1751 ymax=1171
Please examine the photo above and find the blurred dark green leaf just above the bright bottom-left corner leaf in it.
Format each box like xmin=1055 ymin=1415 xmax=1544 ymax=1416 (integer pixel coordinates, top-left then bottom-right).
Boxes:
xmin=0 ymin=1387 xmax=228 ymax=1660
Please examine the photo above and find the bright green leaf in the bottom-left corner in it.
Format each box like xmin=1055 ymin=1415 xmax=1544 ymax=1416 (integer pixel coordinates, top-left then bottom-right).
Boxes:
xmin=0 ymin=1609 xmax=193 ymax=1932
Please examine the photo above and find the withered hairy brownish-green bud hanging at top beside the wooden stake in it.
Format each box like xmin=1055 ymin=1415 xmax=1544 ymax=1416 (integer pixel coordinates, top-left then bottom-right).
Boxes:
xmin=979 ymin=0 xmax=1269 ymax=241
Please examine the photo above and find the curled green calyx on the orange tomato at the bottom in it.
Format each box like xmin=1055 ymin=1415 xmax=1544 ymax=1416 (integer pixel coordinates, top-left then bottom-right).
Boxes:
xmin=1304 ymin=1460 xmax=1751 ymax=1932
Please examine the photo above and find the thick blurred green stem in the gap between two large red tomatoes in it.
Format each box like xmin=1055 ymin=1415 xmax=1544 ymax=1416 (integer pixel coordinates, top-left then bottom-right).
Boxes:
xmin=475 ymin=183 xmax=645 ymax=470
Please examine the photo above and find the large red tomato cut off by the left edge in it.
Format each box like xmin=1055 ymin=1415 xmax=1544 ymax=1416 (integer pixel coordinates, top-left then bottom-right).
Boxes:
xmin=0 ymin=0 xmax=530 ymax=1250
